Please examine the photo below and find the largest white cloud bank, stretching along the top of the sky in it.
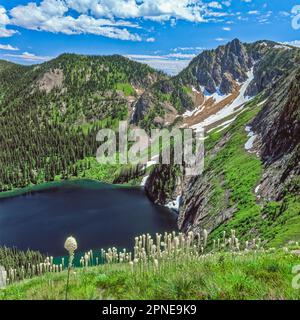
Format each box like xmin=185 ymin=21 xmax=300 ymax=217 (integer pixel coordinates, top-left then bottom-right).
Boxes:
xmin=0 ymin=0 xmax=231 ymax=41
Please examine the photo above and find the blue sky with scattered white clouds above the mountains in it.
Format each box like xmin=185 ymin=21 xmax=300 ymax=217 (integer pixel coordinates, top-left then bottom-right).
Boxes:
xmin=0 ymin=0 xmax=300 ymax=73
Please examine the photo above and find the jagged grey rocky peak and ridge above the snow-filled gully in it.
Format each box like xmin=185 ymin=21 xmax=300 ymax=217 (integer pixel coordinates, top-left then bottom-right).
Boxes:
xmin=132 ymin=39 xmax=300 ymax=129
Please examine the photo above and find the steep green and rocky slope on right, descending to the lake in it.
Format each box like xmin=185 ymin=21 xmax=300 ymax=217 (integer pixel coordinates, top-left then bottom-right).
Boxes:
xmin=178 ymin=70 xmax=300 ymax=239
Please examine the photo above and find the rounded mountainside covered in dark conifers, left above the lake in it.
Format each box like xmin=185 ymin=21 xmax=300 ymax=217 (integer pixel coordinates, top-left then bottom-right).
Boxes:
xmin=0 ymin=54 xmax=165 ymax=191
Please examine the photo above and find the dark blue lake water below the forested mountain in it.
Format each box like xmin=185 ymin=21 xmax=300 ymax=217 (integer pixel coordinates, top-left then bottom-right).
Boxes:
xmin=0 ymin=181 xmax=177 ymax=256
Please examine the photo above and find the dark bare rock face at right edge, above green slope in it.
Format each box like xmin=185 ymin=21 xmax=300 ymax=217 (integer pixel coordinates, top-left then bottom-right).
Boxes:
xmin=252 ymin=69 xmax=300 ymax=200
